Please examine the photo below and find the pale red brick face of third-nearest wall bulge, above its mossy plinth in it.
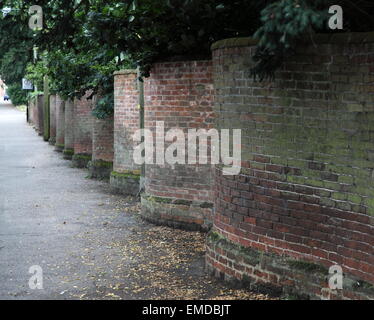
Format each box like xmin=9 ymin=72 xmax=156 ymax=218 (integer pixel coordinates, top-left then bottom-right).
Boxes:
xmin=113 ymin=70 xmax=140 ymax=173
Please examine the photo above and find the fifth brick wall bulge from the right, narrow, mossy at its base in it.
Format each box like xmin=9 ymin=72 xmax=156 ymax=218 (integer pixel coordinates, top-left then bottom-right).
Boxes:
xmin=73 ymin=92 xmax=94 ymax=168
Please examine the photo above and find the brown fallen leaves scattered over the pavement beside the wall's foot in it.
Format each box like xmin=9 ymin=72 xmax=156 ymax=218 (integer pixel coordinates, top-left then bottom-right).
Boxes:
xmin=61 ymin=197 xmax=275 ymax=300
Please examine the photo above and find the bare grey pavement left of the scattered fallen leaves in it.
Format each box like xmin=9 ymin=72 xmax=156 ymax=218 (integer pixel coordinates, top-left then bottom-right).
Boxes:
xmin=0 ymin=104 xmax=137 ymax=299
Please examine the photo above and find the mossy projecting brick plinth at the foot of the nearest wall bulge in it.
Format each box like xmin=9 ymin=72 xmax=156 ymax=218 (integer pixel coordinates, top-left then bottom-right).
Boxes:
xmin=207 ymin=230 xmax=374 ymax=300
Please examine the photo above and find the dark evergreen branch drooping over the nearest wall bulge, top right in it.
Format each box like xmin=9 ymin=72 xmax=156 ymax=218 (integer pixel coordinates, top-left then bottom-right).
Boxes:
xmin=251 ymin=0 xmax=374 ymax=81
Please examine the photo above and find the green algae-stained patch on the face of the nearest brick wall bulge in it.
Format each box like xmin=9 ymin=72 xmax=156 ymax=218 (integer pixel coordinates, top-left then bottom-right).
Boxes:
xmin=248 ymin=76 xmax=374 ymax=215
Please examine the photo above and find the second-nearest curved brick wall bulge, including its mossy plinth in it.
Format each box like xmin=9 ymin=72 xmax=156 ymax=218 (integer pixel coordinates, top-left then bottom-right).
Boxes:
xmin=142 ymin=61 xmax=213 ymax=229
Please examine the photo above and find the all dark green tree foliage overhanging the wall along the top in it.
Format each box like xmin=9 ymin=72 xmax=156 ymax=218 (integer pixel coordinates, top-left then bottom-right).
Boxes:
xmin=0 ymin=0 xmax=374 ymax=109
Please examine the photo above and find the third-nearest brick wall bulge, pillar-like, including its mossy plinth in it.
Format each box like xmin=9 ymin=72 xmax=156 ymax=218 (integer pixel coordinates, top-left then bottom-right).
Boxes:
xmin=110 ymin=70 xmax=141 ymax=195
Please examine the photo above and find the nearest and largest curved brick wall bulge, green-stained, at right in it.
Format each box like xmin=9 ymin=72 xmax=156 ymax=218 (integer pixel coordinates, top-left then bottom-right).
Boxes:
xmin=207 ymin=34 xmax=374 ymax=299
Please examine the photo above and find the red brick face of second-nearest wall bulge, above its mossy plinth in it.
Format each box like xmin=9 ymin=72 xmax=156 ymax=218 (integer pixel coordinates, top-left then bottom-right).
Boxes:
xmin=144 ymin=61 xmax=213 ymax=202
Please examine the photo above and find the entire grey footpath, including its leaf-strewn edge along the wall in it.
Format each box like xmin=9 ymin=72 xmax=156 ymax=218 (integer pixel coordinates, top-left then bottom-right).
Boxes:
xmin=0 ymin=104 xmax=272 ymax=299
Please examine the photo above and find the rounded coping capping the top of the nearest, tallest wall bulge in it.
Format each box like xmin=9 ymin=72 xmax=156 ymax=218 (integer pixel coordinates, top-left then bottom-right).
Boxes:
xmin=211 ymin=32 xmax=374 ymax=51
